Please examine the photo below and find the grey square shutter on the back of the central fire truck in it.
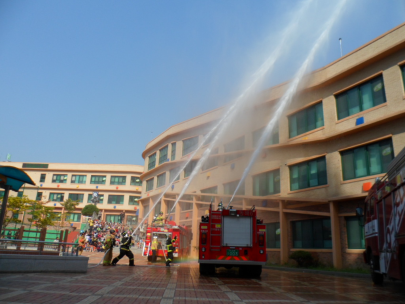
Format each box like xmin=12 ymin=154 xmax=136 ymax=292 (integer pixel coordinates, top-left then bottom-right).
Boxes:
xmin=222 ymin=216 xmax=252 ymax=247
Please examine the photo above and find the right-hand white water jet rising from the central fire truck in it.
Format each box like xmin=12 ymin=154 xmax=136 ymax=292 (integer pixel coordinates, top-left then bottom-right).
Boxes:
xmin=228 ymin=0 xmax=347 ymax=206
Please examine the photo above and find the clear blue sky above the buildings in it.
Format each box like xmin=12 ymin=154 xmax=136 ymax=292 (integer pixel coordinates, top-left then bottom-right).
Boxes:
xmin=0 ymin=0 xmax=405 ymax=165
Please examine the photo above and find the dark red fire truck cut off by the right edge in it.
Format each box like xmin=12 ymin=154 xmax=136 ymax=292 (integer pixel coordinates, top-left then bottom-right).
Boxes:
xmin=362 ymin=149 xmax=405 ymax=284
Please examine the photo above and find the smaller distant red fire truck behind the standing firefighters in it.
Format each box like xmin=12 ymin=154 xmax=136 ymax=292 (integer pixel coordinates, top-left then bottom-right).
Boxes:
xmin=142 ymin=221 xmax=191 ymax=262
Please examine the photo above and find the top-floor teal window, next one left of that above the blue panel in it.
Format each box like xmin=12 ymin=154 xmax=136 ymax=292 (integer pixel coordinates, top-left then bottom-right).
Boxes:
xmin=288 ymin=102 xmax=323 ymax=138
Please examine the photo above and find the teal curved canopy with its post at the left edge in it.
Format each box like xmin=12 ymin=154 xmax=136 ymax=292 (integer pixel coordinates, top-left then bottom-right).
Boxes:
xmin=0 ymin=166 xmax=35 ymax=235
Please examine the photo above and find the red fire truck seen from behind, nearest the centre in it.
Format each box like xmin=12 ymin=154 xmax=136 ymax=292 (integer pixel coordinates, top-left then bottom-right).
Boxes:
xmin=198 ymin=207 xmax=267 ymax=277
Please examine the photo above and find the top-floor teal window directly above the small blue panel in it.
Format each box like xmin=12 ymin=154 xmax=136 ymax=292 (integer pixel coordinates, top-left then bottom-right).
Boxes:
xmin=336 ymin=76 xmax=386 ymax=119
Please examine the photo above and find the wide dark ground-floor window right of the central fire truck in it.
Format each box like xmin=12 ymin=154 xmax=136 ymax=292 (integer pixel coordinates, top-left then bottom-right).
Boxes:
xmin=292 ymin=219 xmax=332 ymax=248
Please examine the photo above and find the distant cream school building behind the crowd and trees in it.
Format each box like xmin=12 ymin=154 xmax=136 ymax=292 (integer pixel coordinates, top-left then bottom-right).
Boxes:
xmin=0 ymin=162 xmax=143 ymax=228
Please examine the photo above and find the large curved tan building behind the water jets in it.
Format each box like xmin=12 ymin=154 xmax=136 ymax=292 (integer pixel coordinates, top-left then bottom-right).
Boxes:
xmin=139 ymin=24 xmax=405 ymax=268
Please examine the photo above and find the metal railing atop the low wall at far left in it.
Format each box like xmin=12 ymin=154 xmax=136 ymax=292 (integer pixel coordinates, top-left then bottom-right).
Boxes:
xmin=0 ymin=239 xmax=79 ymax=256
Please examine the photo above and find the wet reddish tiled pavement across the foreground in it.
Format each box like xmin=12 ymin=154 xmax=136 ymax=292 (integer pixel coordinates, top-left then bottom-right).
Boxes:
xmin=0 ymin=254 xmax=405 ymax=304
